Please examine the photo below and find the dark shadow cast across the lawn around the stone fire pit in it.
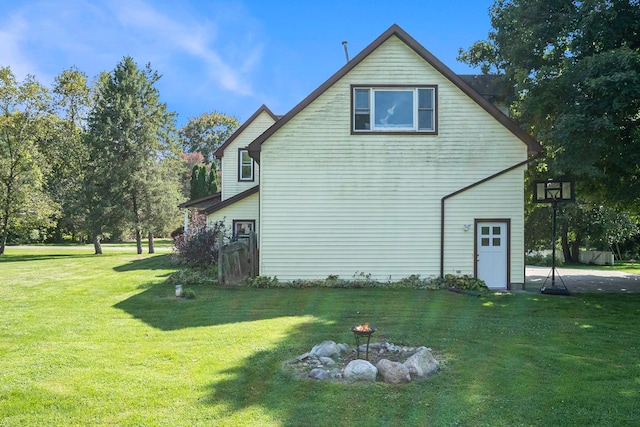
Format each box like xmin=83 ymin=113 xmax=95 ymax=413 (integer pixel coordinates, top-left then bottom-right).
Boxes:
xmin=115 ymin=283 xmax=640 ymax=426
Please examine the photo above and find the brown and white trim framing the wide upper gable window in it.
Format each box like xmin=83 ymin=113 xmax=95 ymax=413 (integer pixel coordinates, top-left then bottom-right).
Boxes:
xmin=350 ymin=84 xmax=438 ymax=135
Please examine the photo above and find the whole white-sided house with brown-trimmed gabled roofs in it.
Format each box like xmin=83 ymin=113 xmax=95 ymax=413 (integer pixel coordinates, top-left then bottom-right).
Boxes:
xmin=206 ymin=25 xmax=542 ymax=289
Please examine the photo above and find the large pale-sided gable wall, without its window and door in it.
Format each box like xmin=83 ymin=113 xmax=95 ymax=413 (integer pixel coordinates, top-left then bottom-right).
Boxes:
xmin=260 ymin=37 xmax=527 ymax=280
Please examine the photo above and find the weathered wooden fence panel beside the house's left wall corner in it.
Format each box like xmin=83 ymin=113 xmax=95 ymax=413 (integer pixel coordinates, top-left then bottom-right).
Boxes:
xmin=218 ymin=233 xmax=258 ymax=285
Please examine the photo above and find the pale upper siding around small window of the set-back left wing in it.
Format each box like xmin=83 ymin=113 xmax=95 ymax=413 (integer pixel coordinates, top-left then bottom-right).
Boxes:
xmin=221 ymin=112 xmax=275 ymax=200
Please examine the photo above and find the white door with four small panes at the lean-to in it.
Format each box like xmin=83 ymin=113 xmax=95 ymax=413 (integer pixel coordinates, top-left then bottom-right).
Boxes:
xmin=476 ymin=222 xmax=507 ymax=289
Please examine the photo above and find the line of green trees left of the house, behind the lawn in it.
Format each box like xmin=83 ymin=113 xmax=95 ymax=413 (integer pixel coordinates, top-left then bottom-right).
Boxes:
xmin=0 ymin=57 xmax=239 ymax=255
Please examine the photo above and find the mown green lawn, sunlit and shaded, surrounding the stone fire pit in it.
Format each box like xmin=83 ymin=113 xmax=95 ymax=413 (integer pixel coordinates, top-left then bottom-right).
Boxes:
xmin=0 ymin=248 xmax=640 ymax=426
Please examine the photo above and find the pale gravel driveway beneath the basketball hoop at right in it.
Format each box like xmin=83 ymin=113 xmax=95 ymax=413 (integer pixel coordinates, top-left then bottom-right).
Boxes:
xmin=526 ymin=266 xmax=640 ymax=293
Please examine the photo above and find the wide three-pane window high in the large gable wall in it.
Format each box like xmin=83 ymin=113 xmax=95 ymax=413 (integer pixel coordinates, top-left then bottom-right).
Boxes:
xmin=353 ymin=86 xmax=436 ymax=133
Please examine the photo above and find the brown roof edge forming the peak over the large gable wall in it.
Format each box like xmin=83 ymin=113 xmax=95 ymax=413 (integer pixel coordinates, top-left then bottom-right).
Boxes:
xmin=249 ymin=24 xmax=544 ymax=163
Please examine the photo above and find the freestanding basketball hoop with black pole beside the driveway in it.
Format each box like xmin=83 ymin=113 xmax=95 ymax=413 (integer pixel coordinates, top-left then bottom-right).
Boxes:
xmin=533 ymin=179 xmax=575 ymax=295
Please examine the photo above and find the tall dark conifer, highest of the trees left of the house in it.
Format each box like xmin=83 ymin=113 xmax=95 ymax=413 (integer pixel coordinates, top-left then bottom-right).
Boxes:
xmin=85 ymin=57 xmax=179 ymax=254
